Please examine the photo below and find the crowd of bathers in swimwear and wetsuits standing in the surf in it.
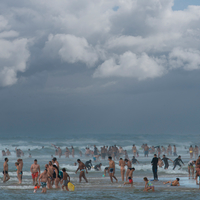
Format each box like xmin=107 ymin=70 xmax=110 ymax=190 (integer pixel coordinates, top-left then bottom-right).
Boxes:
xmin=2 ymin=144 xmax=200 ymax=193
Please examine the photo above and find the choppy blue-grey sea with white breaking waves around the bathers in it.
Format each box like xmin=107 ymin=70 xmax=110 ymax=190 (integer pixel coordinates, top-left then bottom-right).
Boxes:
xmin=0 ymin=133 xmax=200 ymax=199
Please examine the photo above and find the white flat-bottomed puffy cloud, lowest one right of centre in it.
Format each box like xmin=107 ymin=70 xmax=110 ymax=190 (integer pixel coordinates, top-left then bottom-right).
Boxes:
xmin=93 ymin=51 xmax=166 ymax=80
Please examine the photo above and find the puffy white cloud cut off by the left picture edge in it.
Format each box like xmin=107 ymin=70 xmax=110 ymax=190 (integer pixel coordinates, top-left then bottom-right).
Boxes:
xmin=0 ymin=16 xmax=29 ymax=86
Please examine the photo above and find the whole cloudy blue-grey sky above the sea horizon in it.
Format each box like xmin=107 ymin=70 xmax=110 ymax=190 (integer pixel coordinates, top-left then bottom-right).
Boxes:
xmin=0 ymin=0 xmax=200 ymax=135
